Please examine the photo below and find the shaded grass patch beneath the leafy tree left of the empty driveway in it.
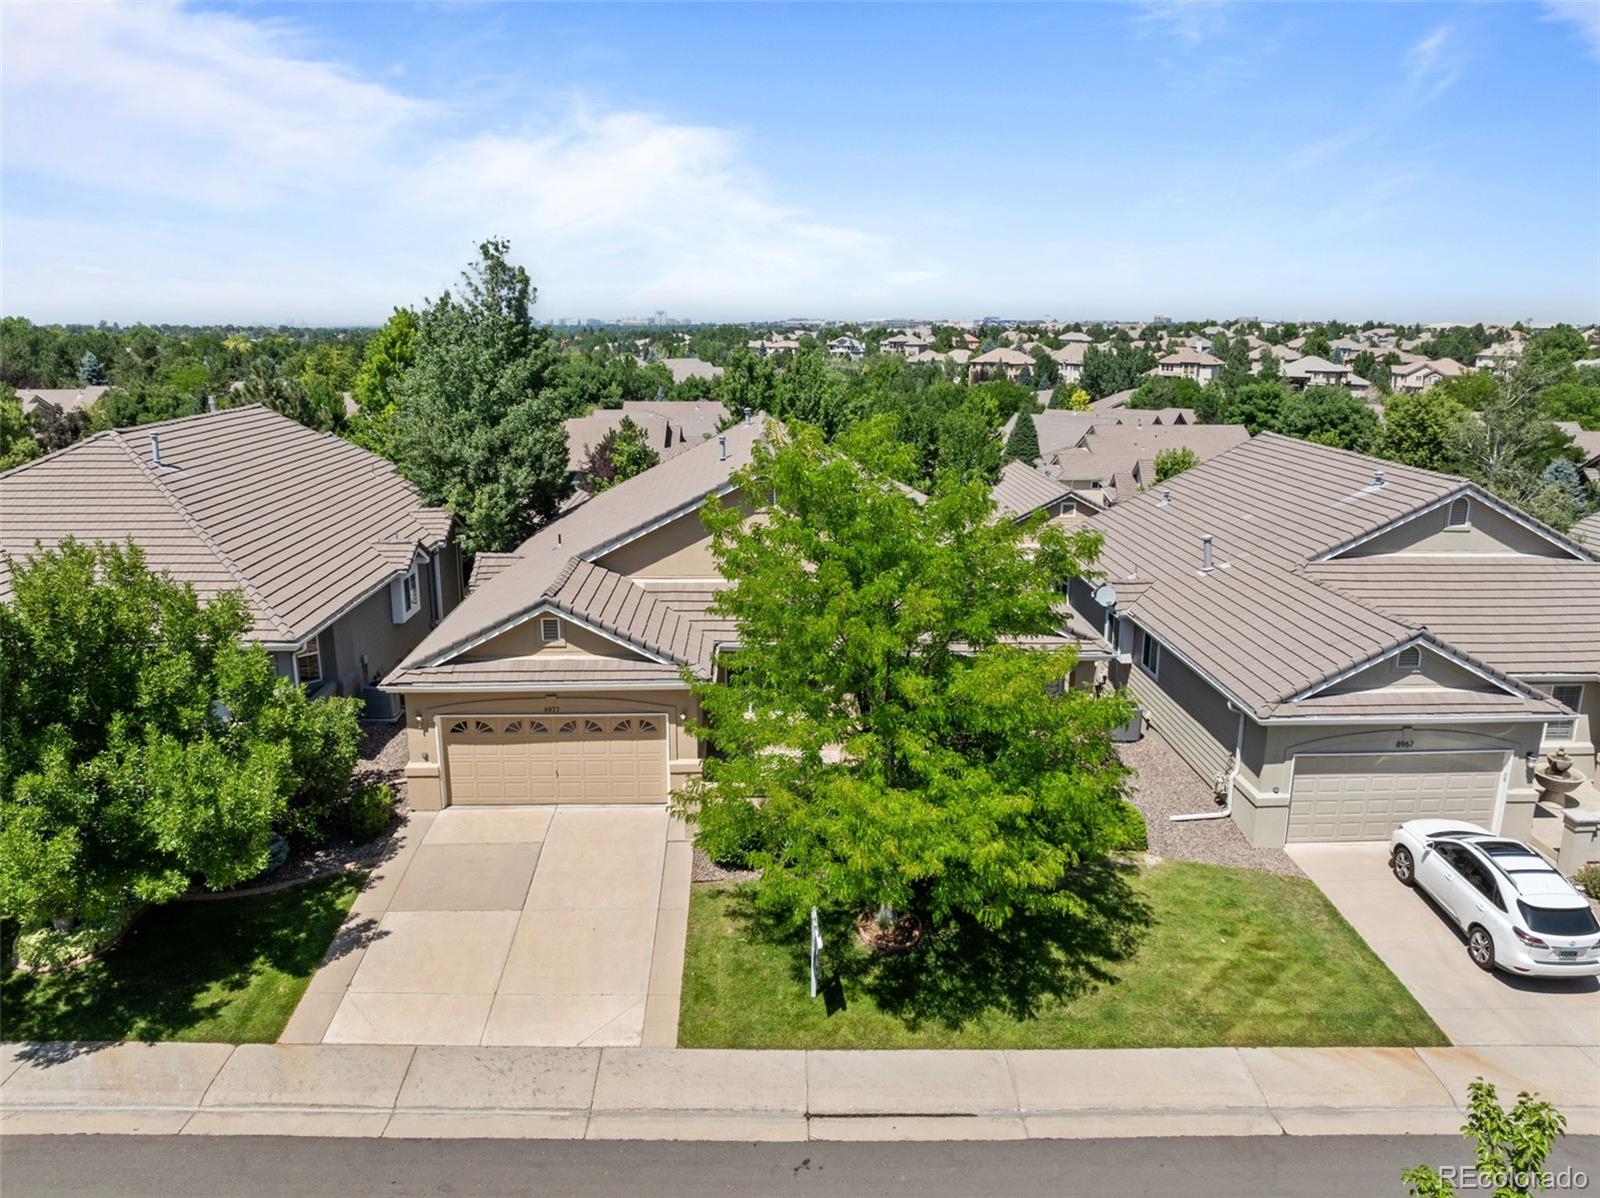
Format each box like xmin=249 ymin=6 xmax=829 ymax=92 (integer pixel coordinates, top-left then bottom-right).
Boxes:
xmin=0 ymin=875 xmax=360 ymax=1044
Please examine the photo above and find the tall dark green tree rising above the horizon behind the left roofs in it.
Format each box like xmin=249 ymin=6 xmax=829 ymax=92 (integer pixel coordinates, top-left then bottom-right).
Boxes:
xmin=394 ymin=240 xmax=576 ymax=553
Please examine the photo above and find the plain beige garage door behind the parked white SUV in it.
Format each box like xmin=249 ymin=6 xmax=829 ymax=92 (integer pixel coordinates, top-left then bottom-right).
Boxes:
xmin=1290 ymin=753 xmax=1506 ymax=843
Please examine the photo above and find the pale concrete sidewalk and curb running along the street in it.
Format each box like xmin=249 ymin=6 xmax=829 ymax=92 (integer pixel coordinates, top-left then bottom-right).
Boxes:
xmin=0 ymin=1044 xmax=1600 ymax=1140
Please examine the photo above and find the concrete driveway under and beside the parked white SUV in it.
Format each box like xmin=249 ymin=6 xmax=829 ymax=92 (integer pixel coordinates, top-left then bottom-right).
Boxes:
xmin=1288 ymin=841 xmax=1600 ymax=1048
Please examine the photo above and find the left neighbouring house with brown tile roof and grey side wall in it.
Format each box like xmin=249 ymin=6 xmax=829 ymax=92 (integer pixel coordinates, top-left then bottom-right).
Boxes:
xmin=0 ymin=405 xmax=462 ymax=694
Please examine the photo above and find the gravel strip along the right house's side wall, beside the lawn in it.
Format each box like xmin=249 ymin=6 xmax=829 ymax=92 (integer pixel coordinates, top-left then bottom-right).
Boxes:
xmin=1117 ymin=729 xmax=1304 ymax=877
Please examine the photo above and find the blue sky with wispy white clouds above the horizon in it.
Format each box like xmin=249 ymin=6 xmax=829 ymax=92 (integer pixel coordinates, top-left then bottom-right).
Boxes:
xmin=0 ymin=0 xmax=1600 ymax=323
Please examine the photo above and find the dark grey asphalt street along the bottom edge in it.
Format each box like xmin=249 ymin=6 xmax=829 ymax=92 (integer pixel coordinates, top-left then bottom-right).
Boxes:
xmin=0 ymin=1136 xmax=1600 ymax=1198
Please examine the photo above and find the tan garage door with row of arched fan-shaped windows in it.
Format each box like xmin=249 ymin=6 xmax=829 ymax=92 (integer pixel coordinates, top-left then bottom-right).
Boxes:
xmin=445 ymin=715 xmax=667 ymax=805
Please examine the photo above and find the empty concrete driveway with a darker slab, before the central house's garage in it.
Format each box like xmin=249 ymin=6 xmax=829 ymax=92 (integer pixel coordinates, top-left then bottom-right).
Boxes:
xmin=283 ymin=806 xmax=690 ymax=1046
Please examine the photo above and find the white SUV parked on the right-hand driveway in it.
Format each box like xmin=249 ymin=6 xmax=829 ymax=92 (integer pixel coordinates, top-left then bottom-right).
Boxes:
xmin=1389 ymin=819 xmax=1600 ymax=977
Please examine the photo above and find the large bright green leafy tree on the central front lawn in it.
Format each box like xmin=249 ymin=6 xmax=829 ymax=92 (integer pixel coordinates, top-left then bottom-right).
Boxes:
xmin=678 ymin=429 xmax=1128 ymax=928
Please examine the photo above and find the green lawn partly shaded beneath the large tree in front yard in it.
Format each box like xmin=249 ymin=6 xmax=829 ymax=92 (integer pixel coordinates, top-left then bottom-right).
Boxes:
xmin=678 ymin=862 xmax=1448 ymax=1048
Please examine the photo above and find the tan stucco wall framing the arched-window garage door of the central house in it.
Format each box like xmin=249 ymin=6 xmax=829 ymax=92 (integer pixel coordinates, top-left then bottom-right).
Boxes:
xmin=396 ymin=688 xmax=701 ymax=811
